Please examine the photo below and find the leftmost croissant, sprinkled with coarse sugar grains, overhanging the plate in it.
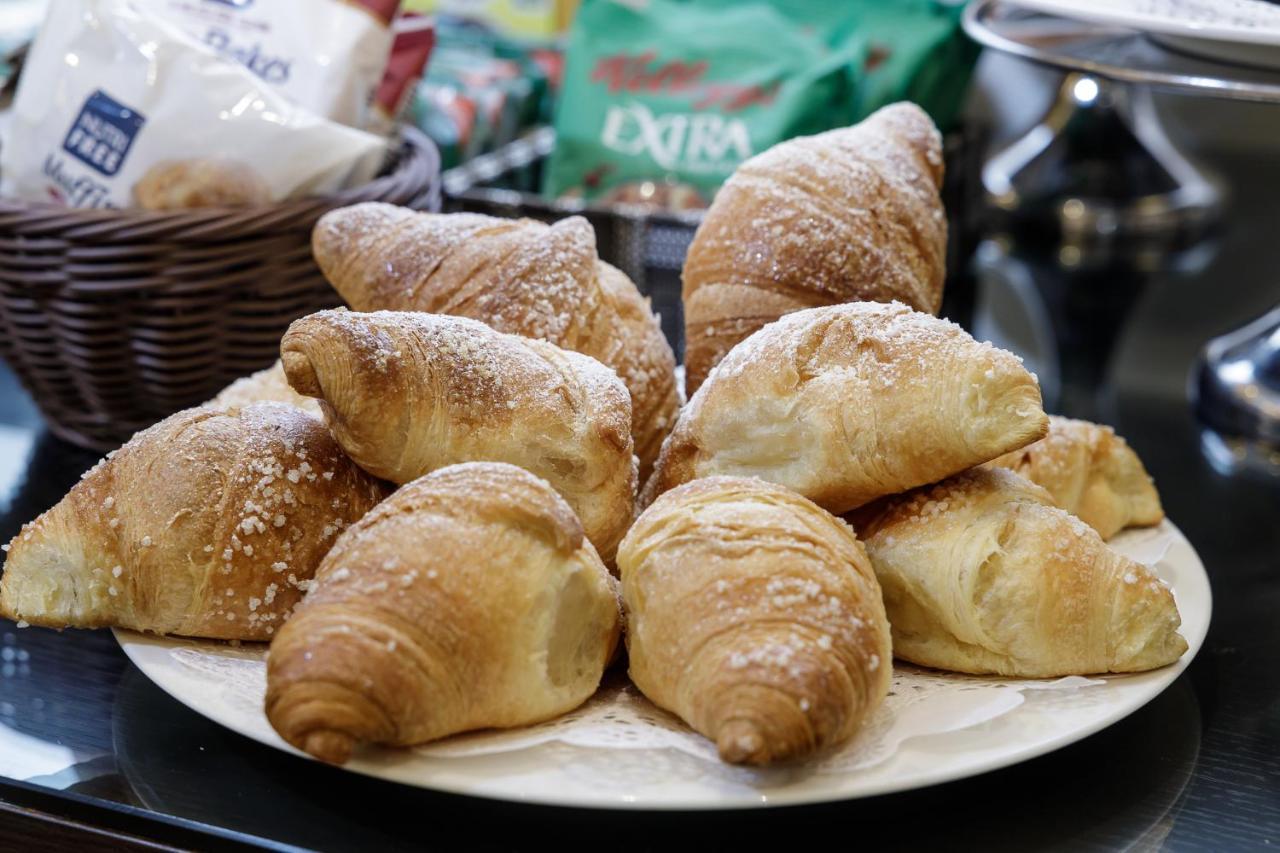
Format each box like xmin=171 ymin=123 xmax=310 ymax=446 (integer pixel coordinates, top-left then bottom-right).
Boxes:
xmin=0 ymin=403 xmax=387 ymax=640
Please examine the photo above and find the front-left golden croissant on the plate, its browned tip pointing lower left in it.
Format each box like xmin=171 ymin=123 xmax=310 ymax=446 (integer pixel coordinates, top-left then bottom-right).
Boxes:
xmin=266 ymin=462 xmax=620 ymax=763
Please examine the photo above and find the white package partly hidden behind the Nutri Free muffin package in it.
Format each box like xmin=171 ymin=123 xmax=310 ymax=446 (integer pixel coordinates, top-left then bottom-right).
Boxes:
xmin=134 ymin=0 xmax=401 ymax=127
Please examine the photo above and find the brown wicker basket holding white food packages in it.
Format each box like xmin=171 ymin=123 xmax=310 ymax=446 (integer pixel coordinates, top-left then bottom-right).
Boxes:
xmin=0 ymin=131 xmax=440 ymax=451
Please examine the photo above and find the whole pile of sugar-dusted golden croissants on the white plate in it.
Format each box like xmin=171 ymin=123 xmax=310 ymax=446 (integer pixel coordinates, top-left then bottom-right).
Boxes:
xmin=0 ymin=104 xmax=1187 ymax=765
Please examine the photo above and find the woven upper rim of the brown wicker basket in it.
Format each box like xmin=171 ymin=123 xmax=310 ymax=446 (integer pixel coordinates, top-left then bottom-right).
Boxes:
xmin=0 ymin=126 xmax=439 ymax=240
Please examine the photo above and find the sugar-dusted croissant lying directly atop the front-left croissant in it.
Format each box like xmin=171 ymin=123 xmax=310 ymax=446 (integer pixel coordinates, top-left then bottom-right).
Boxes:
xmin=280 ymin=311 xmax=636 ymax=561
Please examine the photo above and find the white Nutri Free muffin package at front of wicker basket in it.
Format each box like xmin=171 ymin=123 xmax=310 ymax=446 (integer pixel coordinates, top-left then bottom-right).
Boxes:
xmin=0 ymin=0 xmax=387 ymax=207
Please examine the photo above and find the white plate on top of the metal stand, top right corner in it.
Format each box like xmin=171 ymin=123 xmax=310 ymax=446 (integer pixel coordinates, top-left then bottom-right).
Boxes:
xmin=1007 ymin=0 xmax=1280 ymax=68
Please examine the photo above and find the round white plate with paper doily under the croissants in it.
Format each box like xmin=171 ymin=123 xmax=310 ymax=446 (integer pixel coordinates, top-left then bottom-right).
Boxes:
xmin=115 ymin=521 xmax=1212 ymax=809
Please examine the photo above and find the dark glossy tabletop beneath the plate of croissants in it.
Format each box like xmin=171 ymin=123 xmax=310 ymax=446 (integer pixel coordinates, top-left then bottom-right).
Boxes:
xmin=0 ymin=159 xmax=1280 ymax=850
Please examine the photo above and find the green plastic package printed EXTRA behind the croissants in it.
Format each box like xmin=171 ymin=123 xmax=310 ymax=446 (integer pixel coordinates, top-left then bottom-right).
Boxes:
xmin=544 ymin=0 xmax=864 ymax=207
